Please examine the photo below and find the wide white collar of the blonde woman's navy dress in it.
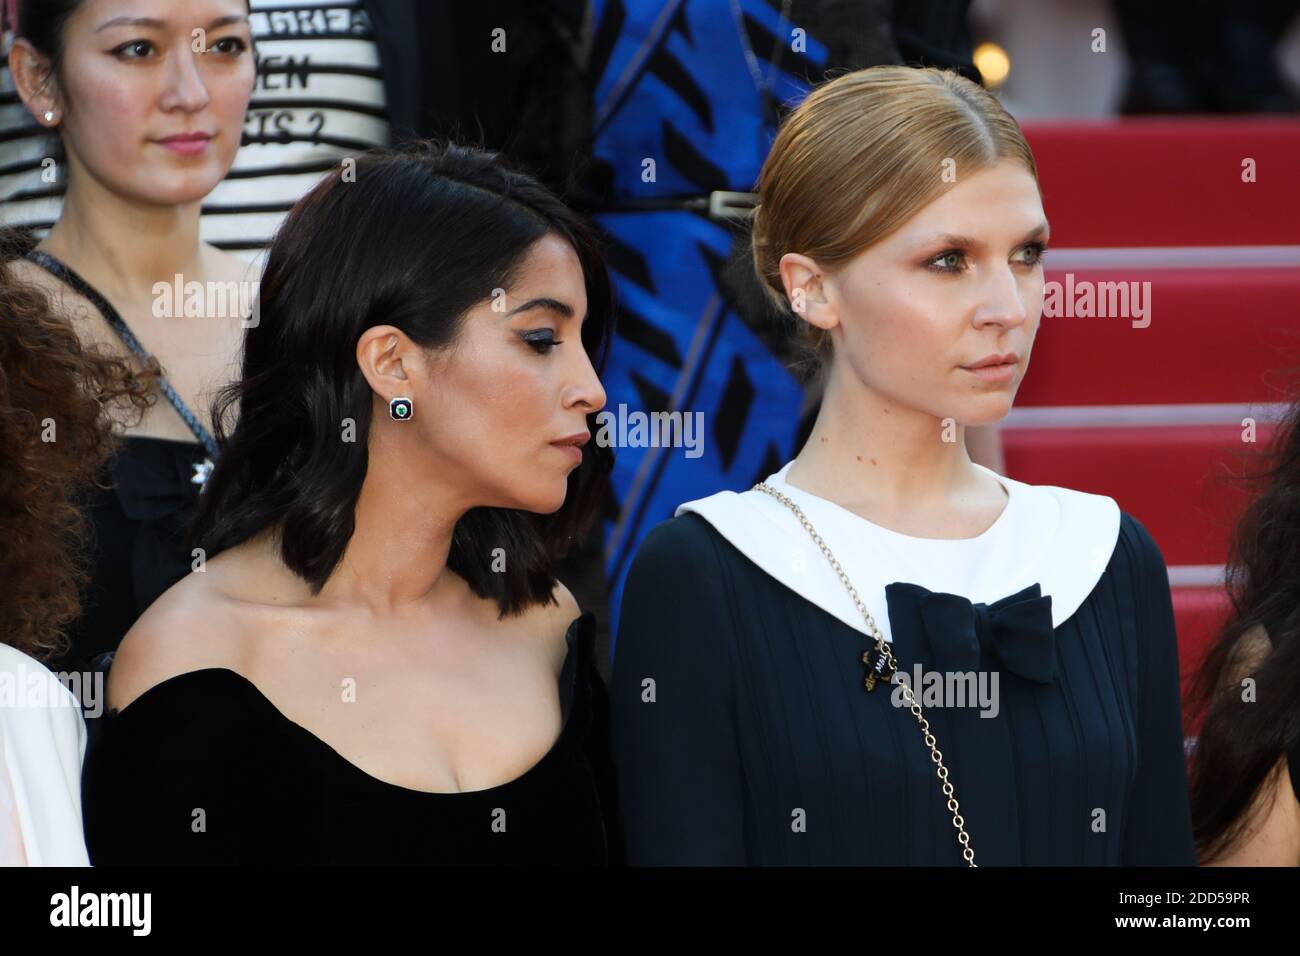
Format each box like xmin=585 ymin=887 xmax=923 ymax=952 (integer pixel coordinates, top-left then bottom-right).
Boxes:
xmin=676 ymin=462 xmax=1119 ymax=640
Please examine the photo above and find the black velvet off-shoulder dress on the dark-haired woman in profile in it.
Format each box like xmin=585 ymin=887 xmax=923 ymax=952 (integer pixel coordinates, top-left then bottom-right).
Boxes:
xmin=82 ymin=613 xmax=623 ymax=866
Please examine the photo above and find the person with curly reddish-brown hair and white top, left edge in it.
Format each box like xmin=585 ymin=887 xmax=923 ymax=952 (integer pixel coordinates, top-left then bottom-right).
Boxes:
xmin=0 ymin=235 xmax=152 ymax=866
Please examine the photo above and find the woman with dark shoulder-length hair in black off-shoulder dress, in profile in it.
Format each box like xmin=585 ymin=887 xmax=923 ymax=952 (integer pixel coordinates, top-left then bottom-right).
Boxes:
xmin=85 ymin=146 xmax=621 ymax=864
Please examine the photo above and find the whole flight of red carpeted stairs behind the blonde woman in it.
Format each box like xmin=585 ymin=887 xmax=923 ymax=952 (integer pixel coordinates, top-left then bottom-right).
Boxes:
xmin=1024 ymin=118 xmax=1300 ymax=732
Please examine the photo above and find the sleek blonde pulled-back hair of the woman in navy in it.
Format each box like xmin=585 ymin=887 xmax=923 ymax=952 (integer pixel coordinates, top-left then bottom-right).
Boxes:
xmin=750 ymin=66 xmax=1037 ymax=378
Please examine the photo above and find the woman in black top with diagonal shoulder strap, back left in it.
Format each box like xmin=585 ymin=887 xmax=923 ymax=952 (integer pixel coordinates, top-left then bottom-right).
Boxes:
xmin=9 ymin=0 xmax=256 ymax=686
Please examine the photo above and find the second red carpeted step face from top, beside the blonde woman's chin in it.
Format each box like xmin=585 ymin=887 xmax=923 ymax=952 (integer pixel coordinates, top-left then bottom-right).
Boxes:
xmin=1015 ymin=265 xmax=1300 ymax=406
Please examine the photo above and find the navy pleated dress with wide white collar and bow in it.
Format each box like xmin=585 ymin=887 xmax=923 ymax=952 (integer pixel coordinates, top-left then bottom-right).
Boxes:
xmin=611 ymin=464 xmax=1195 ymax=866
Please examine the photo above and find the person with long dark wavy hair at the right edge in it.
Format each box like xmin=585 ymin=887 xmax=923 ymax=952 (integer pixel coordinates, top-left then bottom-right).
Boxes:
xmin=1188 ymin=402 xmax=1300 ymax=866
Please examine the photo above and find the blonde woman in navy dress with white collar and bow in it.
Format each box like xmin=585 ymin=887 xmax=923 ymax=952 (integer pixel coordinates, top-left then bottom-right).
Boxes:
xmin=611 ymin=66 xmax=1195 ymax=866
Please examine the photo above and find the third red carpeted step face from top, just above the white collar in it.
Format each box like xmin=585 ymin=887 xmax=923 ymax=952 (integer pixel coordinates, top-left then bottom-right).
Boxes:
xmin=1002 ymin=424 xmax=1273 ymax=566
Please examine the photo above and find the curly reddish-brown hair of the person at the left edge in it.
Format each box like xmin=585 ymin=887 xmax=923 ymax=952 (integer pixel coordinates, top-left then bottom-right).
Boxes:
xmin=0 ymin=233 xmax=157 ymax=661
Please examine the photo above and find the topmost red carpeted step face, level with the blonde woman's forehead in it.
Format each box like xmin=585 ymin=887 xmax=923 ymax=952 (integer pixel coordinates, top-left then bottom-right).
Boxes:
xmin=1024 ymin=118 xmax=1300 ymax=247
